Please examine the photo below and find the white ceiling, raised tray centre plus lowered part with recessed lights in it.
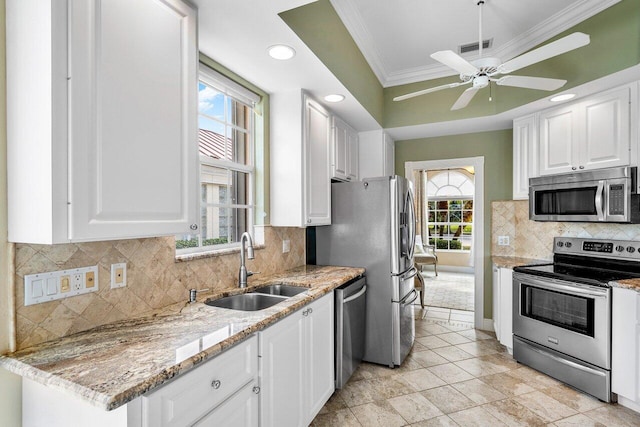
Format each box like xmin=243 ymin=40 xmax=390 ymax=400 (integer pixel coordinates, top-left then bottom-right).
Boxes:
xmin=193 ymin=0 xmax=632 ymax=139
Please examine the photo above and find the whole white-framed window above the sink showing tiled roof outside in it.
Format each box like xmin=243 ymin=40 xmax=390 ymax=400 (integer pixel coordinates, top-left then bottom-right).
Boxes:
xmin=176 ymin=65 xmax=259 ymax=254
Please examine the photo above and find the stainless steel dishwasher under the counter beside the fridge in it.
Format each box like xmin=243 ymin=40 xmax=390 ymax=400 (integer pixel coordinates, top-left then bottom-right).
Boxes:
xmin=334 ymin=277 xmax=367 ymax=389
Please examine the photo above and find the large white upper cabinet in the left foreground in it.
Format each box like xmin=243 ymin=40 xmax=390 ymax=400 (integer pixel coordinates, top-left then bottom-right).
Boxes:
xmin=7 ymin=0 xmax=198 ymax=243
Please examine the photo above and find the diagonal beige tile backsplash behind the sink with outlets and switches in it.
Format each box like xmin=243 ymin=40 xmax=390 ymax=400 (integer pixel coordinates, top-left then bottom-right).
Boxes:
xmin=15 ymin=227 xmax=305 ymax=349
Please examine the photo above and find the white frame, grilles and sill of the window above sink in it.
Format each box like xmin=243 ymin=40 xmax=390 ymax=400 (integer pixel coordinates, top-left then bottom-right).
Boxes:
xmin=175 ymin=63 xmax=260 ymax=258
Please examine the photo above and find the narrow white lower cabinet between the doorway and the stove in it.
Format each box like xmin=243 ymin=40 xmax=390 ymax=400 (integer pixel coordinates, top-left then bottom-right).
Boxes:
xmin=493 ymin=265 xmax=513 ymax=353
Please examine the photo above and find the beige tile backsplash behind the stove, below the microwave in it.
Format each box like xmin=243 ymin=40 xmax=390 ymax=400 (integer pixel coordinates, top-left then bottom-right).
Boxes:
xmin=491 ymin=200 xmax=640 ymax=260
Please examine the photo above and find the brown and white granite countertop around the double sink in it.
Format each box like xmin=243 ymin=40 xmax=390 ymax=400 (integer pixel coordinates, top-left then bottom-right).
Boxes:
xmin=0 ymin=266 xmax=365 ymax=410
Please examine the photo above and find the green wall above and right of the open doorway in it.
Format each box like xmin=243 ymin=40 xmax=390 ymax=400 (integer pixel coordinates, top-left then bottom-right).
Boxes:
xmin=395 ymin=129 xmax=513 ymax=319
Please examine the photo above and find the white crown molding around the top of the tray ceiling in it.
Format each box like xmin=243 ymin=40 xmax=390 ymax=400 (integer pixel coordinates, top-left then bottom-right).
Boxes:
xmin=330 ymin=0 xmax=620 ymax=87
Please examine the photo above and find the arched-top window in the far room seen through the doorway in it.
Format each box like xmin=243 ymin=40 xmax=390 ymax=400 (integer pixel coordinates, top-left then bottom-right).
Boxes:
xmin=426 ymin=169 xmax=475 ymax=251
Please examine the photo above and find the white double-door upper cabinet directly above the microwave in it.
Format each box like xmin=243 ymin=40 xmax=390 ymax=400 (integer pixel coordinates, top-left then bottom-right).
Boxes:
xmin=539 ymin=86 xmax=632 ymax=175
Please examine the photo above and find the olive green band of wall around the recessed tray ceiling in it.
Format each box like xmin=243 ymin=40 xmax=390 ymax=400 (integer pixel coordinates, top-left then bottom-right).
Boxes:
xmin=280 ymin=0 xmax=640 ymax=128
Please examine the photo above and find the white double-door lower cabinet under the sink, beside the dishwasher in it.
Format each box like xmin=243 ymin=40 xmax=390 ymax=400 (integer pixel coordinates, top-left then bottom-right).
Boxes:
xmin=259 ymin=293 xmax=335 ymax=427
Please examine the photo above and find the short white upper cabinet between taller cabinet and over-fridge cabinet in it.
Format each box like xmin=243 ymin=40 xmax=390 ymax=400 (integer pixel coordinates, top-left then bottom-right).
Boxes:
xmin=331 ymin=116 xmax=358 ymax=181
